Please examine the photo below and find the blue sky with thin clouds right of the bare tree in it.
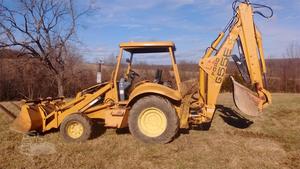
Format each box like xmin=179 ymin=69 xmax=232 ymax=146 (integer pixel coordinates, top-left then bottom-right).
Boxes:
xmin=74 ymin=0 xmax=300 ymax=62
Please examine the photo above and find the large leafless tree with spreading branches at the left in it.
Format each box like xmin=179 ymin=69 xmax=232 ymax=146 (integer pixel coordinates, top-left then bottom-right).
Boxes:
xmin=0 ymin=0 xmax=90 ymax=96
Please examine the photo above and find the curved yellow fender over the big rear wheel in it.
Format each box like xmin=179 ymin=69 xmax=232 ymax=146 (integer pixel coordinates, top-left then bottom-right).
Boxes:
xmin=127 ymin=83 xmax=182 ymax=105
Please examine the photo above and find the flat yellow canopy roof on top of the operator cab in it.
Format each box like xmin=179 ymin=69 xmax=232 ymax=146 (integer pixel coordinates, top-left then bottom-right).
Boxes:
xmin=120 ymin=41 xmax=176 ymax=53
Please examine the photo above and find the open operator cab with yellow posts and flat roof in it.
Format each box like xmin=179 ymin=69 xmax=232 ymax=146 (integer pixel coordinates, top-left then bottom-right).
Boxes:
xmin=116 ymin=41 xmax=180 ymax=101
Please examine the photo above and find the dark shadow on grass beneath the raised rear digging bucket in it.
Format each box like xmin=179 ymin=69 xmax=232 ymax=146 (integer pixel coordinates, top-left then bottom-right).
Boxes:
xmin=216 ymin=105 xmax=253 ymax=129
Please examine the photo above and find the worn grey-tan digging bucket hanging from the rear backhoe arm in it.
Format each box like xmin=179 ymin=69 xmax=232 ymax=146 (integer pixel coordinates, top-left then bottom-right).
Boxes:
xmin=231 ymin=77 xmax=262 ymax=116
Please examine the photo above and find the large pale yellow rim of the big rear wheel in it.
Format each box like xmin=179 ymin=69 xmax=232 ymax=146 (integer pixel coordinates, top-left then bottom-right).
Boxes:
xmin=138 ymin=107 xmax=167 ymax=137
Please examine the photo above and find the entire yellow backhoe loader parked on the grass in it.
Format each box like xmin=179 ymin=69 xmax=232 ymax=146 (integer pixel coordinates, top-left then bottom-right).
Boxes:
xmin=11 ymin=0 xmax=271 ymax=143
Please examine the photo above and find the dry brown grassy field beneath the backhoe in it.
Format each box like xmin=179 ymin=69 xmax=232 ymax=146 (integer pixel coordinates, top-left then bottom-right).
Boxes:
xmin=0 ymin=94 xmax=300 ymax=169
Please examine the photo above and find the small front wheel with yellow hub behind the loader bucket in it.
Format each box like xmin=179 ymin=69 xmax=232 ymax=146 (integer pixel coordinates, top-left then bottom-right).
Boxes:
xmin=60 ymin=113 xmax=92 ymax=142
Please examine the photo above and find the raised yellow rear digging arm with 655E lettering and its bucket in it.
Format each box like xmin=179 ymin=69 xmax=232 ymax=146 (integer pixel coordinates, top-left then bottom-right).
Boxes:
xmin=199 ymin=1 xmax=271 ymax=123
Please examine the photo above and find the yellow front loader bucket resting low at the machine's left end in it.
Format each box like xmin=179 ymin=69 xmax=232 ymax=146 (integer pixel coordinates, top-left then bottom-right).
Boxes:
xmin=10 ymin=104 xmax=43 ymax=133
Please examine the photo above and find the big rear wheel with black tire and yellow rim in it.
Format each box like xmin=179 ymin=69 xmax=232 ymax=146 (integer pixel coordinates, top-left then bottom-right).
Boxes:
xmin=128 ymin=96 xmax=179 ymax=144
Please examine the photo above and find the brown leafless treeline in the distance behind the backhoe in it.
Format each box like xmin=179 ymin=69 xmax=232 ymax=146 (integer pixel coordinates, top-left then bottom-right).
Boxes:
xmin=0 ymin=48 xmax=300 ymax=100
